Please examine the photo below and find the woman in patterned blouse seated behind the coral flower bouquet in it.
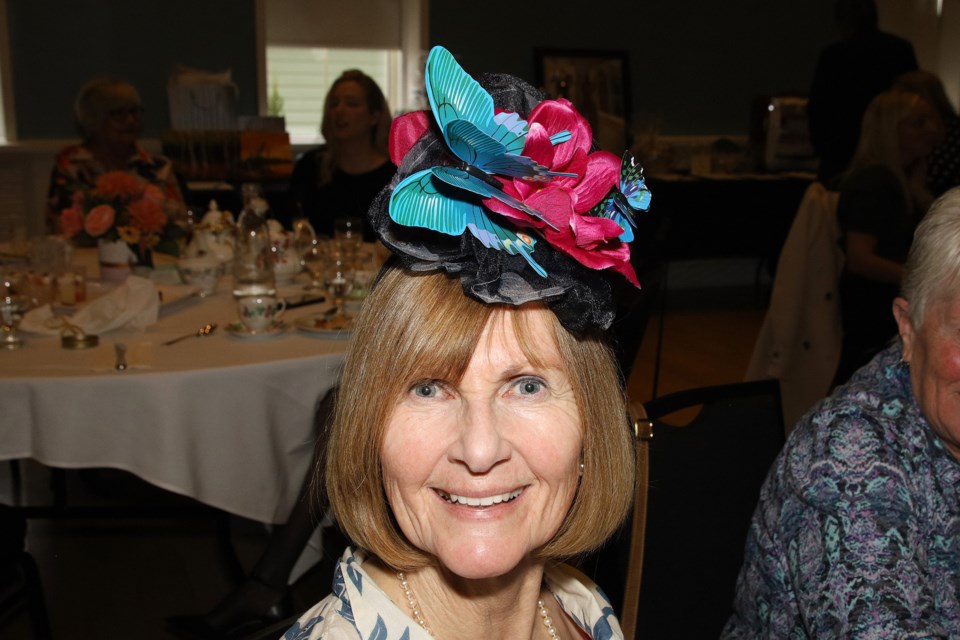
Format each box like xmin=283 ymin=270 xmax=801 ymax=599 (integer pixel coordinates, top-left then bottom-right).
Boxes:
xmin=47 ymin=78 xmax=184 ymax=233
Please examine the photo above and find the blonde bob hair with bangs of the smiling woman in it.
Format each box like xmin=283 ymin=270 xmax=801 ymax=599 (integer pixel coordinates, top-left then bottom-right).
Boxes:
xmin=326 ymin=267 xmax=636 ymax=570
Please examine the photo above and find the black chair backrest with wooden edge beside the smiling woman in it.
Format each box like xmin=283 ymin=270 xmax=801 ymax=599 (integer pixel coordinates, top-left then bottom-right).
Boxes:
xmin=621 ymin=380 xmax=784 ymax=640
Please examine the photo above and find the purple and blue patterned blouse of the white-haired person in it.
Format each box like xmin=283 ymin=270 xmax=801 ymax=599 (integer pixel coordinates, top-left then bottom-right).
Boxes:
xmin=722 ymin=345 xmax=960 ymax=639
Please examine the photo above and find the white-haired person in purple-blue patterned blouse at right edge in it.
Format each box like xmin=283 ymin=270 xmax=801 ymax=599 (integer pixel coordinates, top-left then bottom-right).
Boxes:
xmin=723 ymin=184 xmax=960 ymax=639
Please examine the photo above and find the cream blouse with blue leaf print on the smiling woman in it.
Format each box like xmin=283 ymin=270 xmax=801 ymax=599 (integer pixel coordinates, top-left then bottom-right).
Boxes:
xmin=284 ymin=548 xmax=623 ymax=640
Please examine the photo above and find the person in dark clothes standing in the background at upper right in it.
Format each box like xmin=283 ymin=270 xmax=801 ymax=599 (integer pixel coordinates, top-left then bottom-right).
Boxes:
xmin=807 ymin=0 xmax=917 ymax=188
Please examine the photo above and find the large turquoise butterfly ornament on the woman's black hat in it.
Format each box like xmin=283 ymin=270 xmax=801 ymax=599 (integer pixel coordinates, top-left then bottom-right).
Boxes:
xmin=389 ymin=47 xmax=576 ymax=277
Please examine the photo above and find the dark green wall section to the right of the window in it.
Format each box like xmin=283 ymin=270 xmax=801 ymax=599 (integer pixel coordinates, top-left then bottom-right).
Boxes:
xmin=430 ymin=0 xmax=835 ymax=134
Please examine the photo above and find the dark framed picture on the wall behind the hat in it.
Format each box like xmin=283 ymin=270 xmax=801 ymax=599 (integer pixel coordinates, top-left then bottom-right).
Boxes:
xmin=534 ymin=49 xmax=630 ymax=154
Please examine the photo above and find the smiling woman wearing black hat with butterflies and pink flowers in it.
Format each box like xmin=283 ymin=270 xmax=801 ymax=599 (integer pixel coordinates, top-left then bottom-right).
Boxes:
xmin=288 ymin=48 xmax=636 ymax=640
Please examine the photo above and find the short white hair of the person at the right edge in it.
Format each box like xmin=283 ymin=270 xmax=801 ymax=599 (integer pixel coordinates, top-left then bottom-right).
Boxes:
xmin=900 ymin=187 xmax=960 ymax=329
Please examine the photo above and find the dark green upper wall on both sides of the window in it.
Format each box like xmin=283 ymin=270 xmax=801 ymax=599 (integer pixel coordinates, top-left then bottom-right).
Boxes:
xmin=7 ymin=0 xmax=834 ymax=139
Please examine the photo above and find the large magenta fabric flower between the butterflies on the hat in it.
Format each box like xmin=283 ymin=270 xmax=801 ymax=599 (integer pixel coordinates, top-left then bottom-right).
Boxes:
xmin=484 ymin=99 xmax=640 ymax=287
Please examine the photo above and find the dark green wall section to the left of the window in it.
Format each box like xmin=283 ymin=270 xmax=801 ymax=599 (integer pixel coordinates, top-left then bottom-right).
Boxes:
xmin=7 ymin=0 xmax=257 ymax=140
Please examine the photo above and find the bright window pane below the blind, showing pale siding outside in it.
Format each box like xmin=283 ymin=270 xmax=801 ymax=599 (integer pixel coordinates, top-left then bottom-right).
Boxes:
xmin=267 ymin=45 xmax=403 ymax=144
